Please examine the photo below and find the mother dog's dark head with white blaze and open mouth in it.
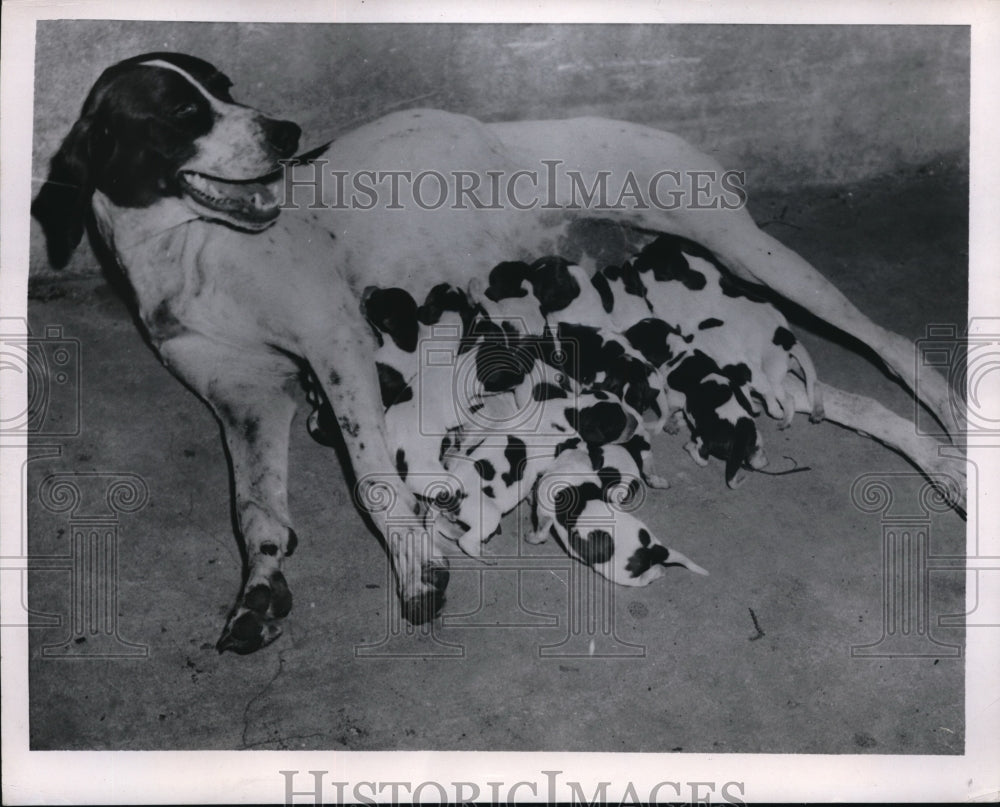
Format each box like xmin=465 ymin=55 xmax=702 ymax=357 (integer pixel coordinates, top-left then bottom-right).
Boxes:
xmin=32 ymin=53 xmax=301 ymax=266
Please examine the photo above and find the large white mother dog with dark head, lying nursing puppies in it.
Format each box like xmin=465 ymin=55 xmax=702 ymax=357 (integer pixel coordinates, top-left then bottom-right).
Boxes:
xmin=32 ymin=53 xmax=962 ymax=652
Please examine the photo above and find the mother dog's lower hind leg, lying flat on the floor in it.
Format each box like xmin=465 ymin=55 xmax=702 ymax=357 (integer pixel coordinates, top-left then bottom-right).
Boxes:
xmin=785 ymin=375 xmax=966 ymax=515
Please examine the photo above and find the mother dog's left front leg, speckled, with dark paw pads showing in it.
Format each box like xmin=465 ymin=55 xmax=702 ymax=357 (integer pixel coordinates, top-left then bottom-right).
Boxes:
xmin=160 ymin=335 xmax=297 ymax=653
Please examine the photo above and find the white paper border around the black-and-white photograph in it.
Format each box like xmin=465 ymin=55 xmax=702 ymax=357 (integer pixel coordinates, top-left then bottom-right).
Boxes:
xmin=0 ymin=0 xmax=1000 ymax=804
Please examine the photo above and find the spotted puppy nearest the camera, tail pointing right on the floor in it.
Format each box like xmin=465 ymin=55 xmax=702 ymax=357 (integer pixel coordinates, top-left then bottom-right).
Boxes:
xmin=528 ymin=445 xmax=708 ymax=586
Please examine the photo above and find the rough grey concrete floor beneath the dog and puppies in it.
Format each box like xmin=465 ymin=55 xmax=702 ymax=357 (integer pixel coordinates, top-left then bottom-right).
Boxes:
xmin=28 ymin=166 xmax=967 ymax=754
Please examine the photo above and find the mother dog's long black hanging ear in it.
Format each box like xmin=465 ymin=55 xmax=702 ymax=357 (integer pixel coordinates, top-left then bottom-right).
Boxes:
xmin=31 ymin=115 xmax=104 ymax=269
